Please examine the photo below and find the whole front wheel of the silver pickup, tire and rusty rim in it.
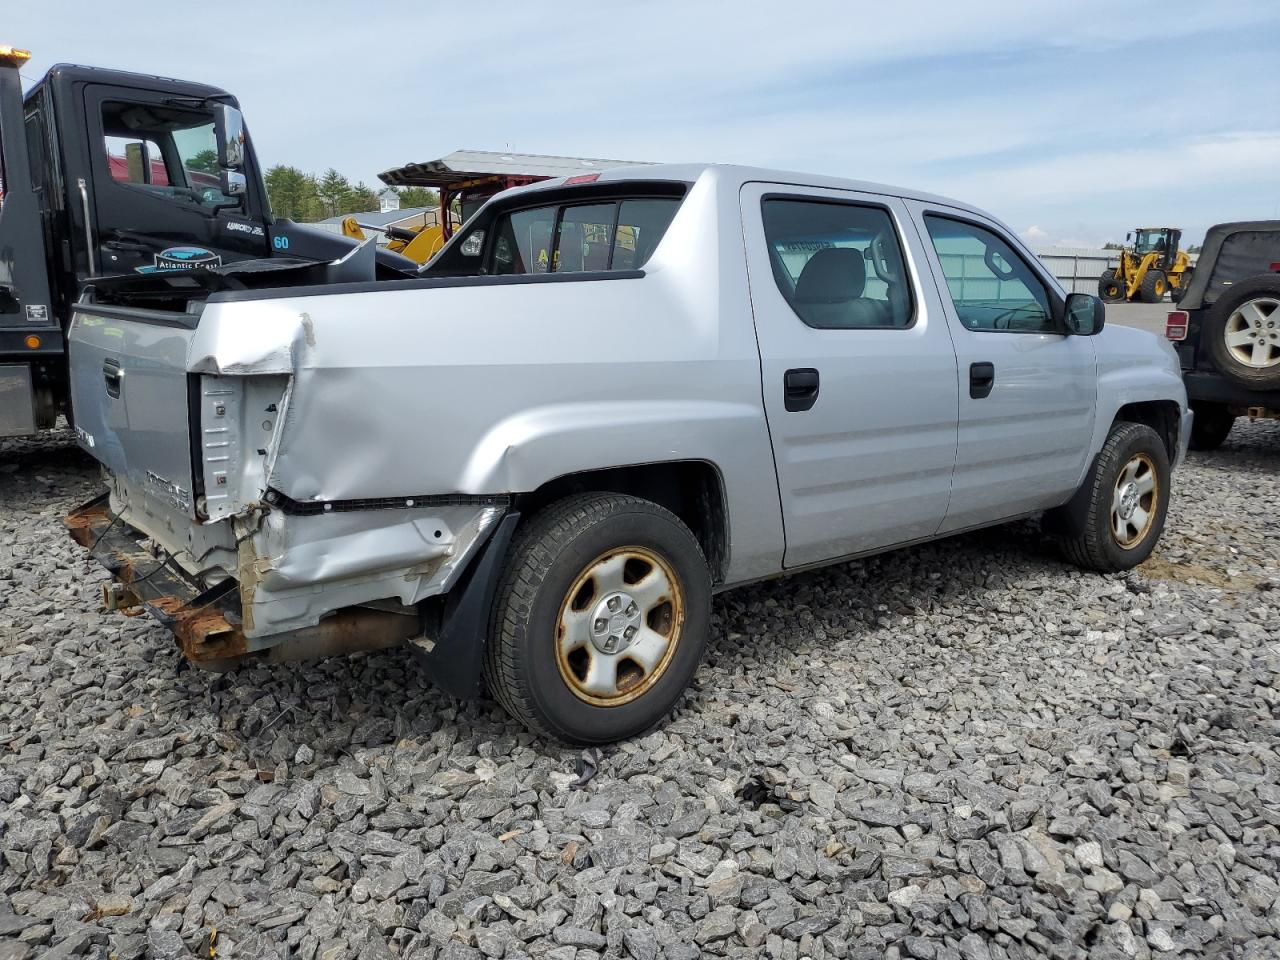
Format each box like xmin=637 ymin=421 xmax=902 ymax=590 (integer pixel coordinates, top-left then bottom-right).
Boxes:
xmin=1061 ymin=422 xmax=1169 ymax=572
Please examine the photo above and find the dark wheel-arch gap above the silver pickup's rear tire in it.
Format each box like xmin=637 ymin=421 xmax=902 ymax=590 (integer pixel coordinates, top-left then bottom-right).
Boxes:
xmin=515 ymin=460 xmax=730 ymax=584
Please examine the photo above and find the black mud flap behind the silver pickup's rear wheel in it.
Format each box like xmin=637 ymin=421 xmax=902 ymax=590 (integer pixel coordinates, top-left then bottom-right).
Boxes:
xmin=410 ymin=511 xmax=520 ymax=700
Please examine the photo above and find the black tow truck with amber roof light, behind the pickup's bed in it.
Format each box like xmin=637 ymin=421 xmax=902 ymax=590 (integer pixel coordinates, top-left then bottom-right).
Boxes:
xmin=0 ymin=46 xmax=417 ymax=438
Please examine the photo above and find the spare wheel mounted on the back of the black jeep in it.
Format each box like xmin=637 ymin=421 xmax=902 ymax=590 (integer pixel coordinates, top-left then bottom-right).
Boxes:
xmin=1201 ymin=276 xmax=1280 ymax=390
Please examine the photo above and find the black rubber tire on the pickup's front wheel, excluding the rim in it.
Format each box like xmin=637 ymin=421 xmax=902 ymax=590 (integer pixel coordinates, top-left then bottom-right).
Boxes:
xmin=1060 ymin=422 xmax=1170 ymax=573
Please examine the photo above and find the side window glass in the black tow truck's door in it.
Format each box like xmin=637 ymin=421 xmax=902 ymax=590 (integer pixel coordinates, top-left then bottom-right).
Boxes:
xmin=102 ymin=102 xmax=236 ymax=206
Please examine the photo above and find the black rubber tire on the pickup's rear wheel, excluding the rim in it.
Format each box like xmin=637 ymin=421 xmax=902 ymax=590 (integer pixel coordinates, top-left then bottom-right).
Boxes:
xmin=485 ymin=493 xmax=712 ymax=744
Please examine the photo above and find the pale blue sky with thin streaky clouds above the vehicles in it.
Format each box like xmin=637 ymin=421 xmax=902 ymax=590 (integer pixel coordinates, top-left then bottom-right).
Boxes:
xmin=10 ymin=0 xmax=1280 ymax=246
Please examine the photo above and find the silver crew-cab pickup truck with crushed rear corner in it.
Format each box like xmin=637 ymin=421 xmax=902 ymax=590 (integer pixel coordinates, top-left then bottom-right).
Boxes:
xmin=67 ymin=165 xmax=1190 ymax=742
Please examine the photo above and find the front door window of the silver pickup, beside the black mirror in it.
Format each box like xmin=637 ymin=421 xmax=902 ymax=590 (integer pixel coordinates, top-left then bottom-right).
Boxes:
xmin=924 ymin=215 xmax=1059 ymax=333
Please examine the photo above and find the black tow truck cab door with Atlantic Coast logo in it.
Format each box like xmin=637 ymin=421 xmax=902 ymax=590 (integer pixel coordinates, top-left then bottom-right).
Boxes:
xmin=80 ymin=83 xmax=270 ymax=274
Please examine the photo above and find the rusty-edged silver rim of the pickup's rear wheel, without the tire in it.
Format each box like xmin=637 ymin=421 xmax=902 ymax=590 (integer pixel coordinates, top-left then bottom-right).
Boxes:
xmin=556 ymin=547 xmax=685 ymax=707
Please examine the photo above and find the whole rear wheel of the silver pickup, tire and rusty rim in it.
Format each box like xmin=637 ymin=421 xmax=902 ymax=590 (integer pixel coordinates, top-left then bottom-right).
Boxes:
xmin=485 ymin=493 xmax=712 ymax=744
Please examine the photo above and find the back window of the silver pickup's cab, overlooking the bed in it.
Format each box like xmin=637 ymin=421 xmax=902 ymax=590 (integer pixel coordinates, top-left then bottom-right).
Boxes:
xmin=492 ymin=197 xmax=680 ymax=275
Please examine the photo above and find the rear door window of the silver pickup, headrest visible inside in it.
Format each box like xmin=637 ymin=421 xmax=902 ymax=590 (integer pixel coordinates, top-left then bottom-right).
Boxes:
xmin=763 ymin=197 xmax=915 ymax=330
